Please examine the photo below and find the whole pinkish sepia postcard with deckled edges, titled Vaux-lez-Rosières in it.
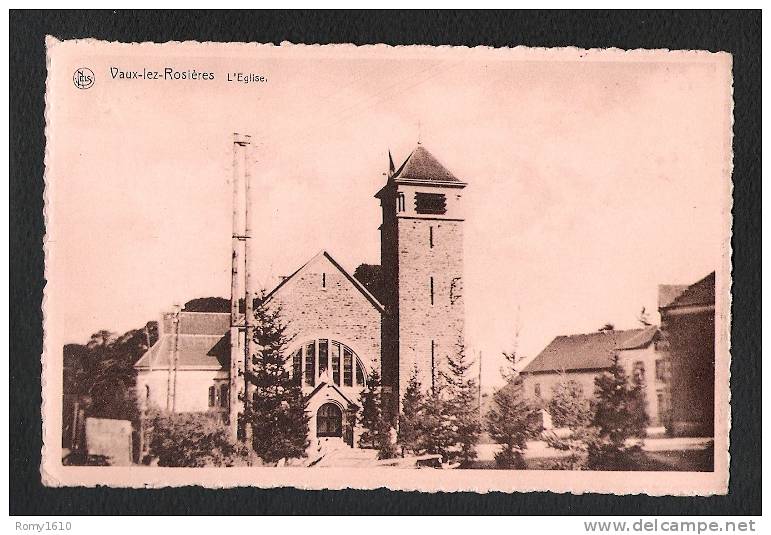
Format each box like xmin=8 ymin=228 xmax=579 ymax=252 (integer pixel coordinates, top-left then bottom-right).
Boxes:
xmin=40 ymin=36 xmax=733 ymax=495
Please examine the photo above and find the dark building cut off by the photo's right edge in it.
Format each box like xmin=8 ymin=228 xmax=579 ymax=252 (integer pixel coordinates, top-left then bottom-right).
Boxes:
xmin=659 ymin=271 xmax=715 ymax=436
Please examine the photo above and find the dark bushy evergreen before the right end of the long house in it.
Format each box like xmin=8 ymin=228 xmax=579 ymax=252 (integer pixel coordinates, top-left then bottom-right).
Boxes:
xmin=588 ymin=355 xmax=648 ymax=470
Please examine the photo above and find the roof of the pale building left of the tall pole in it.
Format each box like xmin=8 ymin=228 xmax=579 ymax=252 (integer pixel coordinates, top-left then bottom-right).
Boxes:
xmin=134 ymin=312 xmax=230 ymax=369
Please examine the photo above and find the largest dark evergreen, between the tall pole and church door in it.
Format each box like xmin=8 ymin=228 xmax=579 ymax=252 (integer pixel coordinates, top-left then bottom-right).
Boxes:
xmin=244 ymin=305 xmax=309 ymax=463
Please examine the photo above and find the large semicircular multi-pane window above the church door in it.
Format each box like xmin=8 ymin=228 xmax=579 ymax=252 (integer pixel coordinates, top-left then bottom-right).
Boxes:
xmin=292 ymin=338 xmax=366 ymax=387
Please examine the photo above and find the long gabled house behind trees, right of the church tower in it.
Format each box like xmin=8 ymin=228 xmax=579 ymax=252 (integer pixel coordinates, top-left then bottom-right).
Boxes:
xmin=520 ymin=325 xmax=669 ymax=427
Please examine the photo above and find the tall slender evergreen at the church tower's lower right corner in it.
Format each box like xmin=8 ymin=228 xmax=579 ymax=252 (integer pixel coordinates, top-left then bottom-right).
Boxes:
xmin=440 ymin=339 xmax=481 ymax=466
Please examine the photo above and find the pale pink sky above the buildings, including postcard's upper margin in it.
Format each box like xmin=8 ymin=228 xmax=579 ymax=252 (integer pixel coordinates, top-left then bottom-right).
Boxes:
xmin=46 ymin=41 xmax=731 ymax=385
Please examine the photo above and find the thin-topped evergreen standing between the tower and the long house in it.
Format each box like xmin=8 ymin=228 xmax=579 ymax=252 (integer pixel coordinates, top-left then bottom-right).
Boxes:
xmin=485 ymin=351 xmax=541 ymax=468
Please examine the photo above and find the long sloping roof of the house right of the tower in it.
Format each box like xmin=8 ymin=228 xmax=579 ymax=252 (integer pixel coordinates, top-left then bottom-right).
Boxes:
xmin=520 ymin=326 xmax=658 ymax=374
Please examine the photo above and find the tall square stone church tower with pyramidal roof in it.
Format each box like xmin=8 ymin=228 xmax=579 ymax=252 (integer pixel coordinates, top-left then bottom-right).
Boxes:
xmin=375 ymin=144 xmax=466 ymax=414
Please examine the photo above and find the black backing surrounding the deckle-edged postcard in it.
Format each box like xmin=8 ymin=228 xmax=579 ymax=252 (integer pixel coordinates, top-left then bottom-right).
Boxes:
xmin=8 ymin=10 xmax=761 ymax=515
